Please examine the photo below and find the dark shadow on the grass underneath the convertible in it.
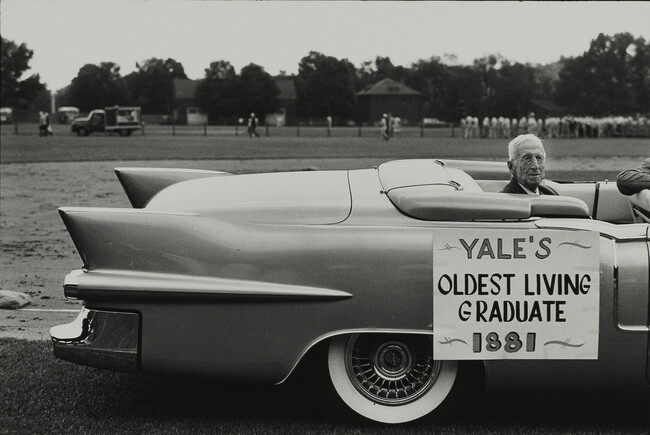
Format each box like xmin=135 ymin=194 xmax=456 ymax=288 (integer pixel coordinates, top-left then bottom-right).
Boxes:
xmin=77 ymin=373 xmax=650 ymax=433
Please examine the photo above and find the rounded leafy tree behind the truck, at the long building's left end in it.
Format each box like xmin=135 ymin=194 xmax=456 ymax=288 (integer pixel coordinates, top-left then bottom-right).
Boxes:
xmin=124 ymin=57 xmax=187 ymax=113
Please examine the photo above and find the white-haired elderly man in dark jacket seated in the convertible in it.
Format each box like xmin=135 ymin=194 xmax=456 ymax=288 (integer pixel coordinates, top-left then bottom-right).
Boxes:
xmin=501 ymin=134 xmax=557 ymax=195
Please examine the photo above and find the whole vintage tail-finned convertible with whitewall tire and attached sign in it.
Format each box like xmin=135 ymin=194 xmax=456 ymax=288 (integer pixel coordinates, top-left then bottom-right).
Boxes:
xmin=51 ymin=159 xmax=650 ymax=423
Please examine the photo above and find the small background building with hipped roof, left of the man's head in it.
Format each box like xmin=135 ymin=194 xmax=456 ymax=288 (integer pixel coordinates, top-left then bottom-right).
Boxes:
xmin=357 ymin=79 xmax=423 ymax=123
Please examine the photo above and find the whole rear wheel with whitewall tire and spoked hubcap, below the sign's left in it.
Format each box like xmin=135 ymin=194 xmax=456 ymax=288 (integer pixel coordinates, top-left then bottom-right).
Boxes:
xmin=328 ymin=334 xmax=457 ymax=423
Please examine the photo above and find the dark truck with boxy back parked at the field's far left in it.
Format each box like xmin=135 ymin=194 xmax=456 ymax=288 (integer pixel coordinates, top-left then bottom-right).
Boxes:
xmin=71 ymin=106 xmax=142 ymax=136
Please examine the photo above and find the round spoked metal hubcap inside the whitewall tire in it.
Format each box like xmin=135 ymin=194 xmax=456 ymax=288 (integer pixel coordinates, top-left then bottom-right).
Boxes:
xmin=345 ymin=334 xmax=440 ymax=405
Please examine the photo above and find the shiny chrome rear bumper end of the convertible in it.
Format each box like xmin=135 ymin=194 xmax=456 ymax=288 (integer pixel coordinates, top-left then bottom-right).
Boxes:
xmin=50 ymin=308 xmax=140 ymax=372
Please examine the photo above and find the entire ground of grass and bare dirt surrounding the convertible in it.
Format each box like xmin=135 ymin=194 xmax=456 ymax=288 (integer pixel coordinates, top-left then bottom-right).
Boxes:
xmin=0 ymin=125 xmax=650 ymax=434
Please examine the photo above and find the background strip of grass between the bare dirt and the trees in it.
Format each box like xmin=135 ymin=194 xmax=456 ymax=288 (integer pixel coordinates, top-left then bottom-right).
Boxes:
xmin=0 ymin=125 xmax=650 ymax=180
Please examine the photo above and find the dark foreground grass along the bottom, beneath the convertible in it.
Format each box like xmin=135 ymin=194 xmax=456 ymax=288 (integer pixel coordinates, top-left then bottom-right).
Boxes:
xmin=0 ymin=339 xmax=648 ymax=435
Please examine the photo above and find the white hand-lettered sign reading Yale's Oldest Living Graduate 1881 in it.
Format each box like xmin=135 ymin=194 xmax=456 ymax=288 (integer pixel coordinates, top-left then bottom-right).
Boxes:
xmin=433 ymin=229 xmax=600 ymax=359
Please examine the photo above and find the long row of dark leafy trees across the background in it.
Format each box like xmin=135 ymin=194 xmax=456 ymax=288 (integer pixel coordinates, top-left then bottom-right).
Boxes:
xmin=2 ymin=33 xmax=650 ymax=122
